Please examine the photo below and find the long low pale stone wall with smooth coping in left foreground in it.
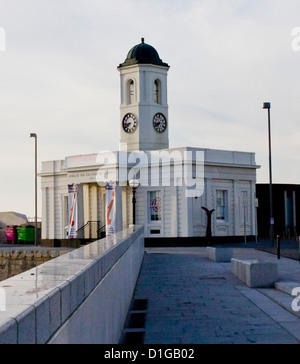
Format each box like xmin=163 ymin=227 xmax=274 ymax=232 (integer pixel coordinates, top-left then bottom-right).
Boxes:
xmin=0 ymin=227 xmax=144 ymax=344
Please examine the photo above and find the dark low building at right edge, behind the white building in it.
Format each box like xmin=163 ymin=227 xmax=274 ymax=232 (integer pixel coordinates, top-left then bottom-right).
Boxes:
xmin=256 ymin=184 xmax=300 ymax=239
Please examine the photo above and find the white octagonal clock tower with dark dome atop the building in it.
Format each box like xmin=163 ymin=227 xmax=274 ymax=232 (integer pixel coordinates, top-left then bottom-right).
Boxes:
xmin=118 ymin=38 xmax=170 ymax=152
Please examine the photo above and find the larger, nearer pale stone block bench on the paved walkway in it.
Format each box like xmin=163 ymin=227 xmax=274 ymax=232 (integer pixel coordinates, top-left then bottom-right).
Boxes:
xmin=231 ymin=259 xmax=278 ymax=288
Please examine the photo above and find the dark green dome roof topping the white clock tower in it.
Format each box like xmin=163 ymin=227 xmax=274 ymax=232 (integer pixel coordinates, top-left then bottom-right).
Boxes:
xmin=119 ymin=38 xmax=169 ymax=68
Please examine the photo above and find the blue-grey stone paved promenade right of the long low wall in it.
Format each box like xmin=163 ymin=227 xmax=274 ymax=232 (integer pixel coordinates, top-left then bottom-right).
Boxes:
xmin=135 ymin=248 xmax=300 ymax=344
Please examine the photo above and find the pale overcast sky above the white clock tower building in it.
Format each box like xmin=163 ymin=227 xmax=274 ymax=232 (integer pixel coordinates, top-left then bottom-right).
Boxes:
xmin=0 ymin=0 xmax=300 ymax=216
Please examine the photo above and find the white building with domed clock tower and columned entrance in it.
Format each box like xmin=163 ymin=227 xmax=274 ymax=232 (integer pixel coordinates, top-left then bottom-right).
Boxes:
xmin=41 ymin=39 xmax=258 ymax=245
